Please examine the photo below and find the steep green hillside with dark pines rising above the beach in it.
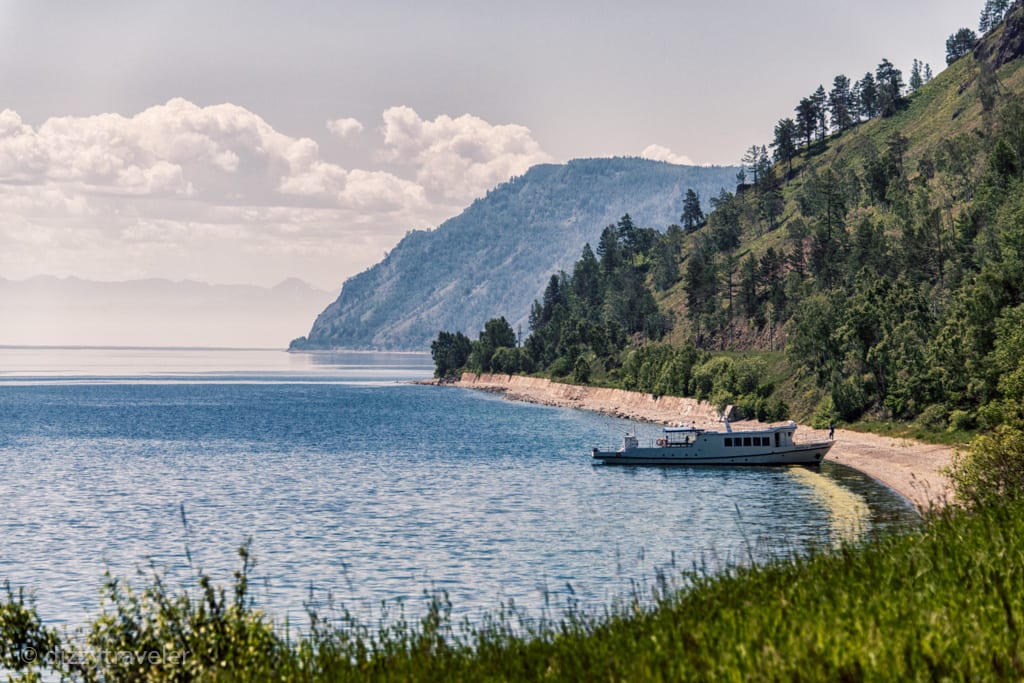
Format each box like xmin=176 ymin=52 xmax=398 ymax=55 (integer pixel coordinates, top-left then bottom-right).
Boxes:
xmin=433 ymin=0 xmax=1024 ymax=432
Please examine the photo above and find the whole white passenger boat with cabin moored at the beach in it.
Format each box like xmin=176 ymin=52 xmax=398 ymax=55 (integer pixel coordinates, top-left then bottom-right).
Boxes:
xmin=592 ymin=421 xmax=834 ymax=465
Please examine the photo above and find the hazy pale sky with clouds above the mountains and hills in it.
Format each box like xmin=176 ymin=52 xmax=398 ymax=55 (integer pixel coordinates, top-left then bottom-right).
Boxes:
xmin=0 ymin=0 xmax=984 ymax=288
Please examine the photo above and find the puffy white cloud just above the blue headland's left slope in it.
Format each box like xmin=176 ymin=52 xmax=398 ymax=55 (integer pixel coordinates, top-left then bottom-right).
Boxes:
xmin=384 ymin=106 xmax=551 ymax=203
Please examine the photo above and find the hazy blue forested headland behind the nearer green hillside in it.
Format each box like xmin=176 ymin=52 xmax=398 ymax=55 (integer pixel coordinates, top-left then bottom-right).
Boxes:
xmin=292 ymin=158 xmax=738 ymax=350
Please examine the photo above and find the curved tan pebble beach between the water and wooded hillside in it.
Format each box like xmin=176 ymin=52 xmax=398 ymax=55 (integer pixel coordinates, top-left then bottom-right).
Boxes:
xmin=417 ymin=373 xmax=955 ymax=512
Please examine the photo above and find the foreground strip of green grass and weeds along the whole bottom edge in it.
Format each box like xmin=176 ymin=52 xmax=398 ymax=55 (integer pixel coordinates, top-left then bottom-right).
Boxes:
xmin=0 ymin=504 xmax=1024 ymax=681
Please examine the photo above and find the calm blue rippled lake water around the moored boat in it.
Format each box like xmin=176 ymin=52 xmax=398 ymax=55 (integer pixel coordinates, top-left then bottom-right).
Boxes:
xmin=0 ymin=348 xmax=913 ymax=625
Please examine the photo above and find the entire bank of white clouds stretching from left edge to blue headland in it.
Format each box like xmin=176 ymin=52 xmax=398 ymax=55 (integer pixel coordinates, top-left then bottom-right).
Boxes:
xmin=0 ymin=98 xmax=549 ymax=288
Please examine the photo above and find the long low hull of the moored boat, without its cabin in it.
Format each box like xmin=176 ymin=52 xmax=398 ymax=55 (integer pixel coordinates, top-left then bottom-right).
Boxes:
xmin=592 ymin=441 xmax=834 ymax=466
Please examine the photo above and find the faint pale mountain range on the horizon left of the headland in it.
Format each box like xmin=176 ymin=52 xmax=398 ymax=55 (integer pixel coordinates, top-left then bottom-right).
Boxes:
xmin=0 ymin=275 xmax=337 ymax=348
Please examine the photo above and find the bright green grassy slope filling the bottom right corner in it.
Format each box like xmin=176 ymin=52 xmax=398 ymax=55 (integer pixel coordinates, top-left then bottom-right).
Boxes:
xmin=450 ymin=509 xmax=1024 ymax=681
